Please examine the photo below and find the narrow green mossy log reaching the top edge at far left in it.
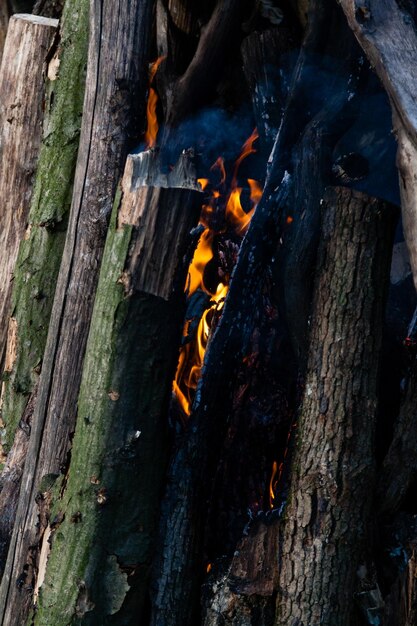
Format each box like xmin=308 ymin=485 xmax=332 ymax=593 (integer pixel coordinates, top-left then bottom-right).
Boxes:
xmin=0 ymin=0 xmax=89 ymax=572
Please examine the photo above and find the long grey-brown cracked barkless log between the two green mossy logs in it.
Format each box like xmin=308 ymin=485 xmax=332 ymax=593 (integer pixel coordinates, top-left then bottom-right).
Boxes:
xmin=0 ymin=0 xmax=153 ymax=624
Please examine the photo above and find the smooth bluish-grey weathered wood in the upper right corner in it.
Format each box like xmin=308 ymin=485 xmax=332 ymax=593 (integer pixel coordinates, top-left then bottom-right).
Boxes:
xmin=338 ymin=0 xmax=417 ymax=288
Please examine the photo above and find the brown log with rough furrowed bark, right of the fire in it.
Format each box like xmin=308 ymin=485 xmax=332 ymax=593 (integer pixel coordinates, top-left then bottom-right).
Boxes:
xmin=276 ymin=188 xmax=395 ymax=626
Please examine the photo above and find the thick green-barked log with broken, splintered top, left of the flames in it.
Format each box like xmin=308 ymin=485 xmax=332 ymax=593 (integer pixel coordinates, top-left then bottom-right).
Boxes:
xmin=30 ymin=155 xmax=201 ymax=625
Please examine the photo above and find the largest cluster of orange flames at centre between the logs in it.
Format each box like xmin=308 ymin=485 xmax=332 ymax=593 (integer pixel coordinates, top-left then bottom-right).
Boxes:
xmin=173 ymin=129 xmax=262 ymax=416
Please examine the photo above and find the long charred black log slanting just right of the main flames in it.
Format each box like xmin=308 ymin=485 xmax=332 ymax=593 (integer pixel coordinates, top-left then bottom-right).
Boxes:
xmin=151 ymin=2 xmax=364 ymax=626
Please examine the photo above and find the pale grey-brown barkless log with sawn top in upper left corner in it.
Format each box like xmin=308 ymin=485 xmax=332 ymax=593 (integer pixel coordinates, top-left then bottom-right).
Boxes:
xmin=0 ymin=15 xmax=58 ymax=365
